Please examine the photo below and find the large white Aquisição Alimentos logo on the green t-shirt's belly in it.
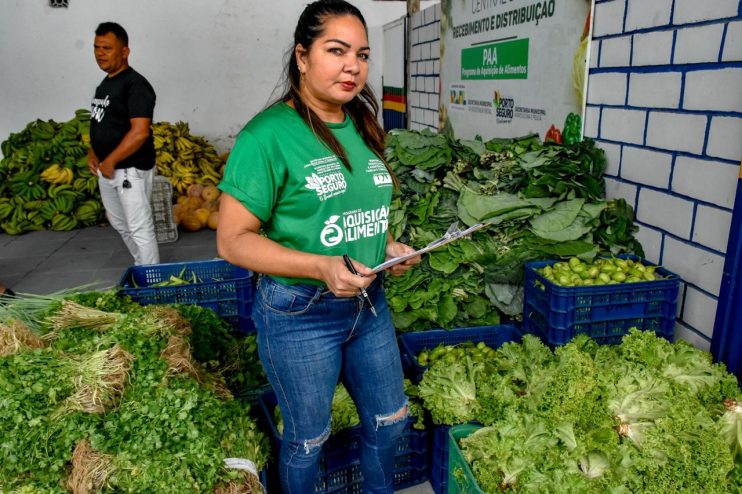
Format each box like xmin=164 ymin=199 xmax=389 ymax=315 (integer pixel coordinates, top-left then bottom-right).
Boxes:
xmin=319 ymin=206 xmax=389 ymax=247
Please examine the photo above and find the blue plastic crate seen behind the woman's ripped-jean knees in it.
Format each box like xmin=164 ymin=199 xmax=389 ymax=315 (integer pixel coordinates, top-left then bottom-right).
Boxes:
xmin=260 ymin=390 xmax=428 ymax=494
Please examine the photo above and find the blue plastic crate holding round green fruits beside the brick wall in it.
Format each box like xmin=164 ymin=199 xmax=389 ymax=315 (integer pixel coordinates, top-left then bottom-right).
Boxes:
xmin=523 ymin=256 xmax=680 ymax=345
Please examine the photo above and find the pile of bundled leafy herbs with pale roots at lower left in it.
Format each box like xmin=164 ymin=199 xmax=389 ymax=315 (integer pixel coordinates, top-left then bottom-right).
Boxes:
xmin=0 ymin=292 xmax=268 ymax=493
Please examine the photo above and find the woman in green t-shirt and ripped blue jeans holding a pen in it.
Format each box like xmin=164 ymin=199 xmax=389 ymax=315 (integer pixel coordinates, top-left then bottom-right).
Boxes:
xmin=217 ymin=0 xmax=419 ymax=493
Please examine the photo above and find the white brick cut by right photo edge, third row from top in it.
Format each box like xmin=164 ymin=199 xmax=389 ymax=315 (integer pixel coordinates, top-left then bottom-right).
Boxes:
xmin=683 ymin=68 xmax=742 ymax=113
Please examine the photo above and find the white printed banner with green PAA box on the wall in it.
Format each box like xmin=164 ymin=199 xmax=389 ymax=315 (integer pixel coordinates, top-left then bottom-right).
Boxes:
xmin=439 ymin=0 xmax=593 ymax=139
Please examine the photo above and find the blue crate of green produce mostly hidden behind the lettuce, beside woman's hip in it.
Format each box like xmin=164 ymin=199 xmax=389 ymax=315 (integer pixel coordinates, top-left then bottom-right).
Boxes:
xmin=399 ymin=324 xmax=523 ymax=383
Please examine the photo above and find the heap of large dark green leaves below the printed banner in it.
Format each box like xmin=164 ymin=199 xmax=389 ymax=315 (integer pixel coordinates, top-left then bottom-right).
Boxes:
xmin=386 ymin=130 xmax=642 ymax=331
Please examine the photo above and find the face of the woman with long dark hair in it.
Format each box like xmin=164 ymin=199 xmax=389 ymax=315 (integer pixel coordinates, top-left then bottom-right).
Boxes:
xmin=296 ymin=15 xmax=370 ymax=115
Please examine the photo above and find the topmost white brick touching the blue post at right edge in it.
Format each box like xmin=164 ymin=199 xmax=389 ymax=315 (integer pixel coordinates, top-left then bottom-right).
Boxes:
xmin=672 ymin=156 xmax=739 ymax=209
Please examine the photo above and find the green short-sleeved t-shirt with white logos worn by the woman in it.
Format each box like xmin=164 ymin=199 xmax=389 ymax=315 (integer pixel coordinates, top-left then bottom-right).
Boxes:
xmin=219 ymin=103 xmax=392 ymax=285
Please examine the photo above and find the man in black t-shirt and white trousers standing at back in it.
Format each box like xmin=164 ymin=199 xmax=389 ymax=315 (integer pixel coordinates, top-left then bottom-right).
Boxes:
xmin=88 ymin=22 xmax=160 ymax=264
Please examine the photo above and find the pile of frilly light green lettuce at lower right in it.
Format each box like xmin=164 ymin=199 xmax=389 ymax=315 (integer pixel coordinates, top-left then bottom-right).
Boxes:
xmin=419 ymin=330 xmax=742 ymax=494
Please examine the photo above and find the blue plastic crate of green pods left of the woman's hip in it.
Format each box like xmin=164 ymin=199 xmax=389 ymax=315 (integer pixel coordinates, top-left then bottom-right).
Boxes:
xmin=119 ymin=259 xmax=255 ymax=333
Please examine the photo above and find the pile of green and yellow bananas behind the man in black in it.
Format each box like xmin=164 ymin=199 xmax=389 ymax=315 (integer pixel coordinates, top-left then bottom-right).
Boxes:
xmin=0 ymin=109 xmax=224 ymax=235
